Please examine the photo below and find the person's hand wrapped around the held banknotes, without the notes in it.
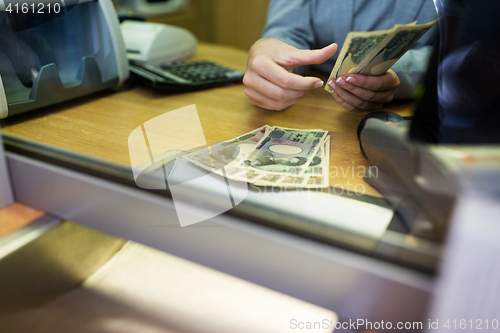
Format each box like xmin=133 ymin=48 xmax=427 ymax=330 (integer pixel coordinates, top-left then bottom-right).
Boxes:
xmin=328 ymin=69 xmax=399 ymax=112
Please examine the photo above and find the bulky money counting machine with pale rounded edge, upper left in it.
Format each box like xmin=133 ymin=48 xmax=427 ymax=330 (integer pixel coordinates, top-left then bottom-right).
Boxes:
xmin=0 ymin=0 xmax=128 ymax=118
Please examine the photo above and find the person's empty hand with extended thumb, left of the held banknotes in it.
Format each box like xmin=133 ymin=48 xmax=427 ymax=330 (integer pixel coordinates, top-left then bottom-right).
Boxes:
xmin=243 ymin=38 xmax=337 ymax=111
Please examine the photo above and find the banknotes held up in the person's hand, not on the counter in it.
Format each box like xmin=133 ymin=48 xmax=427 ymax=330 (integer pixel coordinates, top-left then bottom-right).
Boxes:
xmin=325 ymin=20 xmax=437 ymax=93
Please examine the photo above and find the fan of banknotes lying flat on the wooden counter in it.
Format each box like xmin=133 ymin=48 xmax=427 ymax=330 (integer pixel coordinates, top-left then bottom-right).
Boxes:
xmin=182 ymin=125 xmax=330 ymax=188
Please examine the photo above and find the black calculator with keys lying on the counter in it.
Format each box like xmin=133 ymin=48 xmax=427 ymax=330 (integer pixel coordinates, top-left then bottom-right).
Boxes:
xmin=129 ymin=60 xmax=245 ymax=93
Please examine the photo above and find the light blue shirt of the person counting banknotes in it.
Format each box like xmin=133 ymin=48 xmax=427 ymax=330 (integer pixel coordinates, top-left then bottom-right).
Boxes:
xmin=262 ymin=0 xmax=437 ymax=99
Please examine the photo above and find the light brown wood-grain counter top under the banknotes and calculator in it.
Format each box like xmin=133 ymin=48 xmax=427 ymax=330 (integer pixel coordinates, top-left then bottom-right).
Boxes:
xmin=2 ymin=44 xmax=413 ymax=196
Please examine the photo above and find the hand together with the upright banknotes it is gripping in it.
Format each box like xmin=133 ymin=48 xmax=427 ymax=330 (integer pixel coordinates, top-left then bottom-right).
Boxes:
xmin=325 ymin=21 xmax=437 ymax=112
